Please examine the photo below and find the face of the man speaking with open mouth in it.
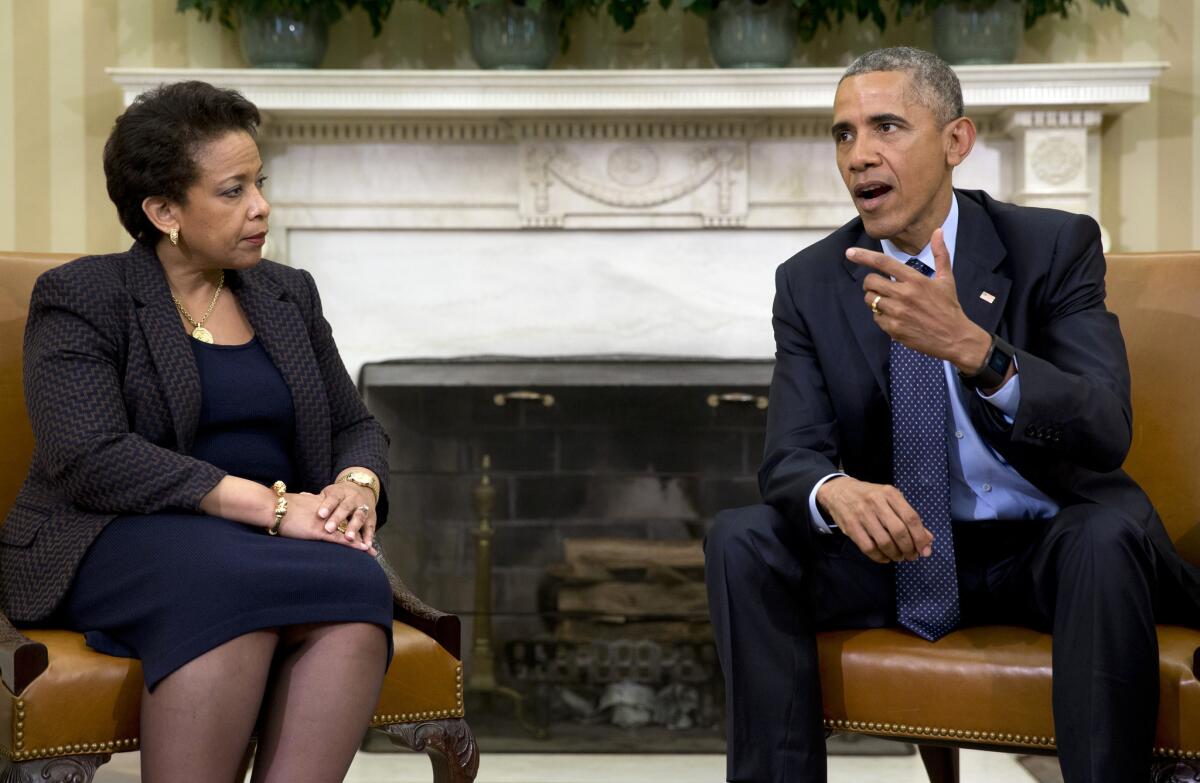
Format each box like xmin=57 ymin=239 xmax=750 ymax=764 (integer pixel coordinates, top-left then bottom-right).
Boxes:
xmin=833 ymin=71 xmax=961 ymax=253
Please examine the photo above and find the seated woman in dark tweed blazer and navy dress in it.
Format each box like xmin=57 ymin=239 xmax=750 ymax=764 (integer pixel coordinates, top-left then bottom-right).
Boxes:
xmin=0 ymin=82 xmax=391 ymax=783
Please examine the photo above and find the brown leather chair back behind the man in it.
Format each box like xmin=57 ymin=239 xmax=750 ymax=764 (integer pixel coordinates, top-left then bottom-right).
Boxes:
xmin=1106 ymin=252 xmax=1200 ymax=564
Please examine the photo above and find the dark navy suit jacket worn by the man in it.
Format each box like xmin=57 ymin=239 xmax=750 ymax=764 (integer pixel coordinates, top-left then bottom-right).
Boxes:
xmin=758 ymin=190 xmax=1200 ymax=606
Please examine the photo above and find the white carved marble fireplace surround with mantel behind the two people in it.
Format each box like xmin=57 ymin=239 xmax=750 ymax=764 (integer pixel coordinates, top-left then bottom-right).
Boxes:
xmin=109 ymin=62 xmax=1166 ymax=375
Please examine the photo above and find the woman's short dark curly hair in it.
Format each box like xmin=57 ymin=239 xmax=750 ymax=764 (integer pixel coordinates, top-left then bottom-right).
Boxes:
xmin=104 ymin=82 xmax=262 ymax=244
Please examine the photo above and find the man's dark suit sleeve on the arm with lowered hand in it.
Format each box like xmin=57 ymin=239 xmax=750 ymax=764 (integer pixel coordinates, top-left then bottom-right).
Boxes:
xmin=758 ymin=264 xmax=839 ymax=527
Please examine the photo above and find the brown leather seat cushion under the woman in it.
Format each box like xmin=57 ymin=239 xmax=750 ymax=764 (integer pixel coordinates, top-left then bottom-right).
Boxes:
xmin=0 ymin=622 xmax=462 ymax=760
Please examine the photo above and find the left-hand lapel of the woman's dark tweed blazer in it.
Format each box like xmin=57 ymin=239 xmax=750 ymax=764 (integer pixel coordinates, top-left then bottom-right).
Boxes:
xmin=126 ymin=243 xmax=200 ymax=454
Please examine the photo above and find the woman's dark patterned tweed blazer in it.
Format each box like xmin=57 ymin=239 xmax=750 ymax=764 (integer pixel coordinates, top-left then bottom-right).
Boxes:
xmin=0 ymin=244 xmax=388 ymax=622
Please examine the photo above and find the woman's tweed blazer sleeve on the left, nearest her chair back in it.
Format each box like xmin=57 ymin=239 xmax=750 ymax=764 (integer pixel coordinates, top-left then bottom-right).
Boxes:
xmin=24 ymin=267 xmax=226 ymax=514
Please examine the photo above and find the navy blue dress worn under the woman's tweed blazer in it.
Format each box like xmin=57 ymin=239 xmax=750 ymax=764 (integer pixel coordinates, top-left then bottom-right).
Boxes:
xmin=59 ymin=337 xmax=391 ymax=689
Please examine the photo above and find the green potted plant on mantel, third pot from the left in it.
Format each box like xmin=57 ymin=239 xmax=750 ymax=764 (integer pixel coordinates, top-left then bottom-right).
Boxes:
xmin=668 ymin=0 xmax=887 ymax=68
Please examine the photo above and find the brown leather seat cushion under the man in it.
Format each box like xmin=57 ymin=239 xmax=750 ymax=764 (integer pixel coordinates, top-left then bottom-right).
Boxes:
xmin=817 ymin=626 xmax=1200 ymax=754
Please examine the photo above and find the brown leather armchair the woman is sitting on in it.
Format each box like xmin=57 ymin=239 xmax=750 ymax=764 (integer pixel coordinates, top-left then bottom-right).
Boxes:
xmin=0 ymin=253 xmax=479 ymax=783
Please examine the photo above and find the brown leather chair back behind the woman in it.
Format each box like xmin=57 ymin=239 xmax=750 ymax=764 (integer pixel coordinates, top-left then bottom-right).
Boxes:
xmin=0 ymin=253 xmax=76 ymax=516
